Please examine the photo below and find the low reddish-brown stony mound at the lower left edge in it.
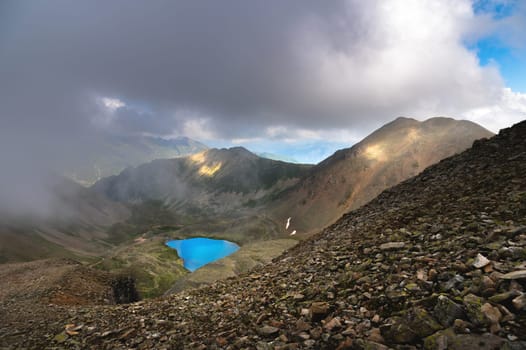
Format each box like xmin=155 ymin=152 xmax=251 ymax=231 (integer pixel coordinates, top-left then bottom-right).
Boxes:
xmin=0 ymin=259 xmax=134 ymax=348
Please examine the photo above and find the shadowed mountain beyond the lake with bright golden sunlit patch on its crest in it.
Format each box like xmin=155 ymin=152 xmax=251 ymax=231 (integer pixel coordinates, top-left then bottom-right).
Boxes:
xmin=93 ymin=147 xmax=312 ymax=216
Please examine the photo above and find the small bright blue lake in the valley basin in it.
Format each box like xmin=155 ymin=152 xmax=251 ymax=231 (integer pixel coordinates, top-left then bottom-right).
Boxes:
xmin=166 ymin=238 xmax=239 ymax=272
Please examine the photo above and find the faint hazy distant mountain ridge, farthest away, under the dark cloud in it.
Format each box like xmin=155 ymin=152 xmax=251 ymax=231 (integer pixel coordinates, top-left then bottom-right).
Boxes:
xmin=66 ymin=136 xmax=208 ymax=186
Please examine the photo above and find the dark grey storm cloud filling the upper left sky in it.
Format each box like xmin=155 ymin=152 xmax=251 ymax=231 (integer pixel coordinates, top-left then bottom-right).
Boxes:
xmin=3 ymin=0 xmax=396 ymax=135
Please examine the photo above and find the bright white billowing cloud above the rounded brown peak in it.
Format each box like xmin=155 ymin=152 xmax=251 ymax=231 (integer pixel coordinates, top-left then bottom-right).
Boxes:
xmin=292 ymin=0 xmax=502 ymax=122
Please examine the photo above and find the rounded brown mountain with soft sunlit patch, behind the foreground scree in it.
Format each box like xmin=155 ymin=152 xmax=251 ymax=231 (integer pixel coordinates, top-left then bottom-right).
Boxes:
xmin=270 ymin=117 xmax=492 ymax=234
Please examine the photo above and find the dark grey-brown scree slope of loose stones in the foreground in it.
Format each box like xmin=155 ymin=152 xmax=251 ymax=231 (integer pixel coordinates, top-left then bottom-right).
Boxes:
xmin=0 ymin=122 xmax=526 ymax=349
